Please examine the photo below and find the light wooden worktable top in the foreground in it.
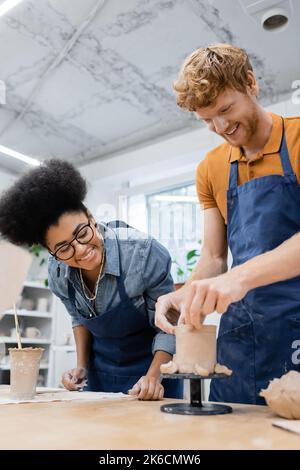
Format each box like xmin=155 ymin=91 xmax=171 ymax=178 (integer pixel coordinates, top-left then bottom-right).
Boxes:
xmin=0 ymin=399 xmax=300 ymax=450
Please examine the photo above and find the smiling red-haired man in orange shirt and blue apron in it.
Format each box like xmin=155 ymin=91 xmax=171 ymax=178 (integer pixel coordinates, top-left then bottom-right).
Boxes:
xmin=156 ymin=44 xmax=300 ymax=403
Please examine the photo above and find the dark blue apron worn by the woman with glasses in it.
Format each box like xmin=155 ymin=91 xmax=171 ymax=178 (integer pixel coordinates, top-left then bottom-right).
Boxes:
xmin=68 ymin=244 xmax=183 ymax=398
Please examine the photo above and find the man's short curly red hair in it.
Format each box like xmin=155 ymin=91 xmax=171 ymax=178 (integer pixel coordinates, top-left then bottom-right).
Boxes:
xmin=173 ymin=44 xmax=253 ymax=111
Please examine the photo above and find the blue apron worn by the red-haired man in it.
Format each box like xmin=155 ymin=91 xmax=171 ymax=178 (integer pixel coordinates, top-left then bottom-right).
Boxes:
xmin=210 ymin=128 xmax=300 ymax=404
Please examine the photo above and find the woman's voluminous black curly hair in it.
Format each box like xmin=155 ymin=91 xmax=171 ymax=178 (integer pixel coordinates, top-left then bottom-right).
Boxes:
xmin=0 ymin=159 xmax=87 ymax=246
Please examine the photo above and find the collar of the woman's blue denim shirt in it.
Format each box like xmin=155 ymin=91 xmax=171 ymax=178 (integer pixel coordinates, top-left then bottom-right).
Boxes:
xmin=65 ymin=222 xmax=120 ymax=282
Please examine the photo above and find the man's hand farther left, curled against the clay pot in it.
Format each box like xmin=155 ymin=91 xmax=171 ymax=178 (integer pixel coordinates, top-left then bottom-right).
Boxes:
xmin=155 ymin=286 xmax=188 ymax=334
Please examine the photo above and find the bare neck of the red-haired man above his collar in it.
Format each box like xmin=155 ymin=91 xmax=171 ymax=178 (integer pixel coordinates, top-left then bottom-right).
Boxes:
xmin=242 ymin=110 xmax=272 ymax=160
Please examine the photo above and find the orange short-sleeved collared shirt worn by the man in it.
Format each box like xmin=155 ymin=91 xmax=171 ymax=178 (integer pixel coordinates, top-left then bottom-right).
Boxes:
xmin=197 ymin=114 xmax=300 ymax=224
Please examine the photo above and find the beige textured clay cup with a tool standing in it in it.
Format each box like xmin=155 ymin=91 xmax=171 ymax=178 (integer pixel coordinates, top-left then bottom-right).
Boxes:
xmin=9 ymin=348 xmax=44 ymax=400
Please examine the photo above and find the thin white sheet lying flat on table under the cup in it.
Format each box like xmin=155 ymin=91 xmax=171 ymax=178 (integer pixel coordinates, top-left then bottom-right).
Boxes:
xmin=0 ymin=386 xmax=132 ymax=405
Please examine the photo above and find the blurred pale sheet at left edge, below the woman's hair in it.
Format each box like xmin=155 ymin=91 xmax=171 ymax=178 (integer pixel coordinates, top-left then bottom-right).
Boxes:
xmin=0 ymin=240 xmax=32 ymax=318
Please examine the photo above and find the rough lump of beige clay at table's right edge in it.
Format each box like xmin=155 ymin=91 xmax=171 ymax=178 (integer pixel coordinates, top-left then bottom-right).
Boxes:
xmin=260 ymin=370 xmax=300 ymax=419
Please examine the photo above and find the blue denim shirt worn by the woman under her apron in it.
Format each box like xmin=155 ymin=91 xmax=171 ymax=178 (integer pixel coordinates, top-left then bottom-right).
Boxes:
xmin=48 ymin=222 xmax=175 ymax=354
